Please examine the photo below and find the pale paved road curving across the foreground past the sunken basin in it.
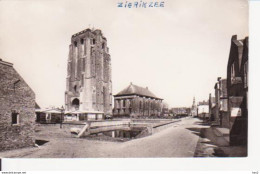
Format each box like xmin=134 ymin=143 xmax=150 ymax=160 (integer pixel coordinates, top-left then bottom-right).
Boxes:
xmin=0 ymin=118 xmax=206 ymax=158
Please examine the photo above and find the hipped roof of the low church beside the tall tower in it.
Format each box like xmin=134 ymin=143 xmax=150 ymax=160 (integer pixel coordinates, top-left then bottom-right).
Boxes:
xmin=114 ymin=83 xmax=161 ymax=99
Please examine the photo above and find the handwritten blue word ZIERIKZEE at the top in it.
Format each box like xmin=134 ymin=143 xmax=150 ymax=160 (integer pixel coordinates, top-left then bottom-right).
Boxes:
xmin=117 ymin=1 xmax=164 ymax=8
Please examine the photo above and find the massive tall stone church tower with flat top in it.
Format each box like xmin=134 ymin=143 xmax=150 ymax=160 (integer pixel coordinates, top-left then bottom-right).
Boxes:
xmin=65 ymin=29 xmax=112 ymax=114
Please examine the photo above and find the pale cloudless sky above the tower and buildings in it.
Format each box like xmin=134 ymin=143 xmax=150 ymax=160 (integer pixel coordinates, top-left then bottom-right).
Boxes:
xmin=0 ymin=0 xmax=248 ymax=107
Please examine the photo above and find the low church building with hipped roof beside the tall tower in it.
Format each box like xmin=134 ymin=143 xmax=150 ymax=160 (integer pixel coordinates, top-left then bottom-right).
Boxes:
xmin=113 ymin=83 xmax=163 ymax=117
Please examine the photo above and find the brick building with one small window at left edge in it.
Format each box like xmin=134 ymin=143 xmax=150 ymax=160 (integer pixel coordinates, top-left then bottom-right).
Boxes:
xmin=0 ymin=59 xmax=35 ymax=151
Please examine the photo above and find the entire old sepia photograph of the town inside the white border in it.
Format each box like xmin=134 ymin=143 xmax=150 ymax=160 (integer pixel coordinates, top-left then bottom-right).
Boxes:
xmin=0 ymin=0 xmax=258 ymax=171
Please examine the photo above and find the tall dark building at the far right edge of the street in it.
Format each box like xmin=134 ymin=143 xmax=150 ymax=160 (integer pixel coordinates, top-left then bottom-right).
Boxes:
xmin=227 ymin=35 xmax=248 ymax=145
